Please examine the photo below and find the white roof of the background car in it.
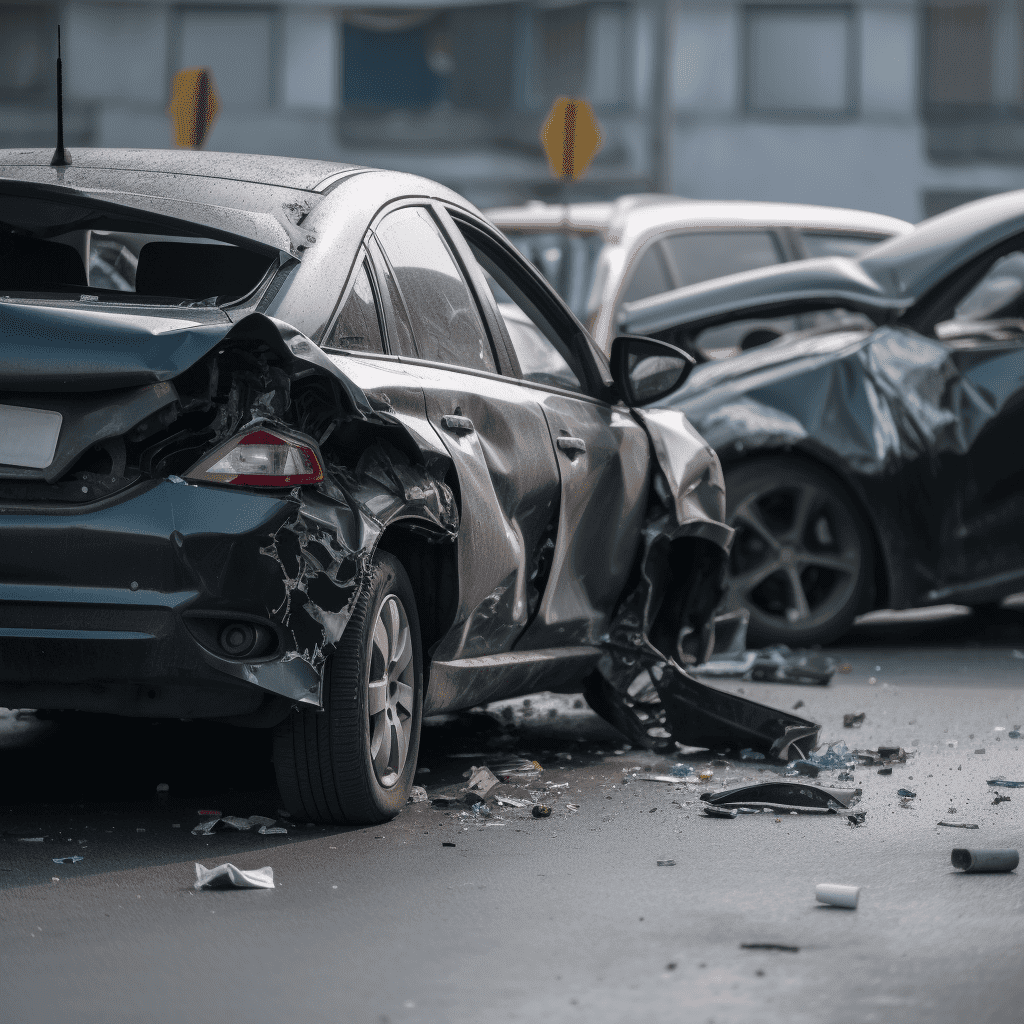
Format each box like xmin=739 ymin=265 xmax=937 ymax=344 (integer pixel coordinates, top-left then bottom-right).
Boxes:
xmin=484 ymin=194 xmax=913 ymax=242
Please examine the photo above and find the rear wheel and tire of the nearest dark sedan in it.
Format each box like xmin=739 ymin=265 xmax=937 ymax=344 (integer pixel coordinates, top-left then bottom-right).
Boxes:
xmin=273 ymin=553 xmax=423 ymax=824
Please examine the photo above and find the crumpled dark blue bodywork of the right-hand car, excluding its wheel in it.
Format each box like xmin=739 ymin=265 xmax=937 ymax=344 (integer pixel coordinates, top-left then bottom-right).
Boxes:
xmin=628 ymin=193 xmax=1024 ymax=610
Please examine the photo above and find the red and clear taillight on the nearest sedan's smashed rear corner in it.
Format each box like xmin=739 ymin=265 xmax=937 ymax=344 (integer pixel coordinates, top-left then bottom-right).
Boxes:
xmin=185 ymin=427 xmax=324 ymax=487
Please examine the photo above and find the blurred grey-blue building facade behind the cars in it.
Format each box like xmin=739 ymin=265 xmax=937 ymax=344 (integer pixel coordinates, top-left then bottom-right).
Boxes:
xmin=0 ymin=0 xmax=1024 ymax=220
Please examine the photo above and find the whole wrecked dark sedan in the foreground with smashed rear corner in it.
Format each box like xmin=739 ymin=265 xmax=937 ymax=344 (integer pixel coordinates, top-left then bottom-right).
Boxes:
xmin=0 ymin=150 xmax=816 ymax=822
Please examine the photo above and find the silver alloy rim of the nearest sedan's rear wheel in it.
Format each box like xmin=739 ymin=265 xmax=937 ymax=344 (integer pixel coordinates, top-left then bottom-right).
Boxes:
xmin=367 ymin=594 xmax=416 ymax=788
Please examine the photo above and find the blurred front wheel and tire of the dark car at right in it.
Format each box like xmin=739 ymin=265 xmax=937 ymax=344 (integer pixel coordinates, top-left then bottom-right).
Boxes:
xmin=725 ymin=456 xmax=872 ymax=648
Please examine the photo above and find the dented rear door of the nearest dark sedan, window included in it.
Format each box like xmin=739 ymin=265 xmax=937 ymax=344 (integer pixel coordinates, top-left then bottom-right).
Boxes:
xmin=375 ymin=206 xmax=559 ymax=667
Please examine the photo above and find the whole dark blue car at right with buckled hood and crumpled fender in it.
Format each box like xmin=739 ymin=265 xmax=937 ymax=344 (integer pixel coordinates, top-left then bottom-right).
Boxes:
xmin=625 ymin=191 xmax=1024 ymax=645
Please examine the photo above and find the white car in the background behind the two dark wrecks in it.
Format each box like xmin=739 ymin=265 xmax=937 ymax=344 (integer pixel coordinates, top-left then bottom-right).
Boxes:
xmin=485 ymin=195 xmax=911 ymax=360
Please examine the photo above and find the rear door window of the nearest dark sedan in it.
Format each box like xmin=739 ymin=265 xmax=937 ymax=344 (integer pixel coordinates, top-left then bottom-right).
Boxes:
xmin=376 ymin=207 xmax=498 ymax=373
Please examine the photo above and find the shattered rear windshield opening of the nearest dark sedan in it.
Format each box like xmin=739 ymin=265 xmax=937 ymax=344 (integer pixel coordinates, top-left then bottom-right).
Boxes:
xmin=0 ymin=194 xmax=274 ymax=306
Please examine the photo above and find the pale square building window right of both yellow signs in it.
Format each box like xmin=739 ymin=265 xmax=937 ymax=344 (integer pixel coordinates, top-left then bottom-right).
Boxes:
xmin=744 ymin=6 xmax=857 ymax=115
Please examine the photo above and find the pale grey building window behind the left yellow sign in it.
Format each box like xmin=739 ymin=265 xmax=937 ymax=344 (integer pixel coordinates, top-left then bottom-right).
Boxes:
xmin=176 ymin=7 xmax=273 ymax=110
